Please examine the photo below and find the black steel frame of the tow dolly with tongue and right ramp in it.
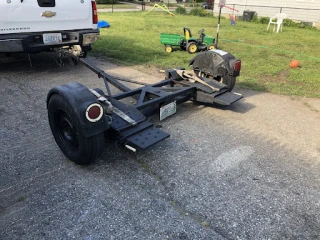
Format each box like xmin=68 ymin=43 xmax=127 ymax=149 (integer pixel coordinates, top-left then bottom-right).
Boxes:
xmin=79 ymin=56 xmax=242 ymax=116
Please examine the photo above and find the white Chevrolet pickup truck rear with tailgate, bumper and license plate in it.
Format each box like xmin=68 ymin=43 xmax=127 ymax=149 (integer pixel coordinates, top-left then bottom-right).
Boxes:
xmin=0 ymin=0 xmax=99 ymax=56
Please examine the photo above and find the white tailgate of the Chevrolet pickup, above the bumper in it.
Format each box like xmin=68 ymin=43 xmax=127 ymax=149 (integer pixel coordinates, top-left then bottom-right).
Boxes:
xmin=0 ymin=0 xmax=96 ymax=34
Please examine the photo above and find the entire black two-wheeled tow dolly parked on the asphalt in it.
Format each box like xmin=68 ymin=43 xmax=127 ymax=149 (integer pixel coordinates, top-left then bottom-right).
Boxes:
xmin=47 ymin=49 xmax=243 ymax=165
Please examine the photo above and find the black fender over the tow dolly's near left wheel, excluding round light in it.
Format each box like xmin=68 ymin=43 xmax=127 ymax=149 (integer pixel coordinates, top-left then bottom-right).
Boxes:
xmin=47 ymin=82 xmax=110 ymax=137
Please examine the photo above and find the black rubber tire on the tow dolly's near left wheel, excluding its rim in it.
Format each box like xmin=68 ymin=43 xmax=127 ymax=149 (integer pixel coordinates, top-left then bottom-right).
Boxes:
xmin=48 ymin=94 xmax=105 ymax=165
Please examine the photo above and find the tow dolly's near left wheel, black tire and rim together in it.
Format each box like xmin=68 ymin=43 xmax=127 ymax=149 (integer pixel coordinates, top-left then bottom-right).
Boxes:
xmin=48 ymin=94 xmax=104 ymax=165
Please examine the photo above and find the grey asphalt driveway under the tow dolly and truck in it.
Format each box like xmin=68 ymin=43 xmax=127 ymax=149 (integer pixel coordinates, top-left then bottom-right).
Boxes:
xmin=0 ymin=54 xmax=320 ymax=240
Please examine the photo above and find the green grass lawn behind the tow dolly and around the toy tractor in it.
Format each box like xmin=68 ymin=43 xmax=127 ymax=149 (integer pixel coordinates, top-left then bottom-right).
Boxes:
xmin=93 ymin=12 xmax=320 ymax=97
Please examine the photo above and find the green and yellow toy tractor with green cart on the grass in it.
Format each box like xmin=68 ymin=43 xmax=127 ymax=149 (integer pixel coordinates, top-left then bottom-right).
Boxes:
xmin=160 ymin=27 xmax=215 ymax=53
